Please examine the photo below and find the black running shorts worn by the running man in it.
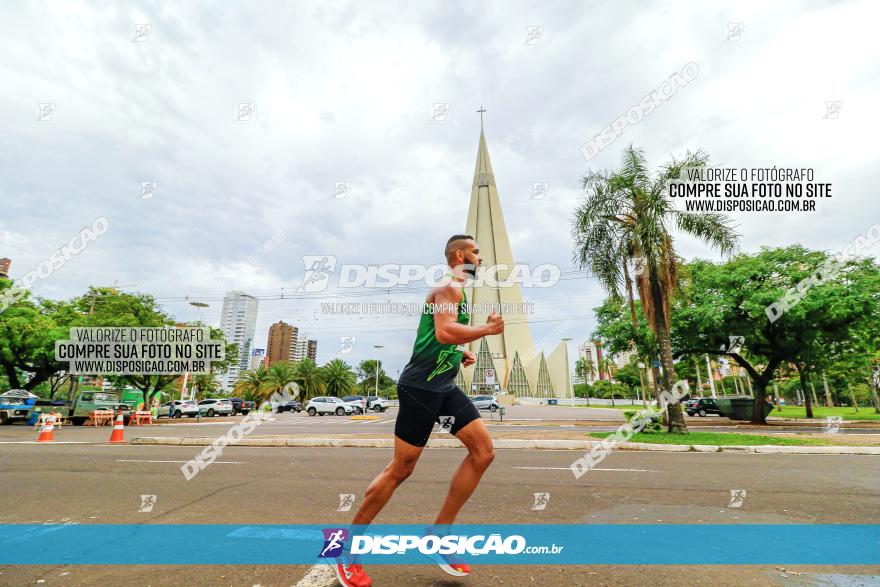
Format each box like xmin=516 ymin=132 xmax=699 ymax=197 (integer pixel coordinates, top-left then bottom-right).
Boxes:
xmin=394 ymin=385 xmax=480 ymax=446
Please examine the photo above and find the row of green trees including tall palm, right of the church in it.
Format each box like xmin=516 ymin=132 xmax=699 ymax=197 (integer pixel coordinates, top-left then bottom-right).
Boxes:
xmin=572 ymin=146 xmax=880 ymax=433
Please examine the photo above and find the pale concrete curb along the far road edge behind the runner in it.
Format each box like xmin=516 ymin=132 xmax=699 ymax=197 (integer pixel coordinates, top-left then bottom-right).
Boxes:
xmin=130 ymin=436 xmax=880 ymax=456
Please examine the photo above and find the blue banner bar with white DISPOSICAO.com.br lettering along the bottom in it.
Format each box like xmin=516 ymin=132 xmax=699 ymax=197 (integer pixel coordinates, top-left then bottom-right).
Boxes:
xmin=0 ymin=524 xmax=880 ymax=565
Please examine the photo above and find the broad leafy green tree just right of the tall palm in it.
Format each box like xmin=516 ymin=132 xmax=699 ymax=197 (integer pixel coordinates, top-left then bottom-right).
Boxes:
xmin=672 ymin=245 xmax=880 ymax=423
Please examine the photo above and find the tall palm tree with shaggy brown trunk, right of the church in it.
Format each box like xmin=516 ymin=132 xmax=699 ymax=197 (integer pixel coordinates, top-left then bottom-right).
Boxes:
xmin=572 ymin=145 xmax=739 ymax=434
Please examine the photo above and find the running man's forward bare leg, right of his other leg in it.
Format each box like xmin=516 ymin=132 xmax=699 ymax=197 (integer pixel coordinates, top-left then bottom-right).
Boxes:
xmin=434 ymin=418 xmax=495 ymax=525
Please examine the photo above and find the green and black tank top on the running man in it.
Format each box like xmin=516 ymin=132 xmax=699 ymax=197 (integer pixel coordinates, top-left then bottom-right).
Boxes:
xmin=398 ymin=290 xmax=471 ymax=391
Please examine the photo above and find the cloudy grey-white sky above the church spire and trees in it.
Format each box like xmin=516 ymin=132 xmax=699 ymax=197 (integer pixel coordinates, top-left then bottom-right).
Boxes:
xmin=0 ymin=1 xmax=880 ymax=375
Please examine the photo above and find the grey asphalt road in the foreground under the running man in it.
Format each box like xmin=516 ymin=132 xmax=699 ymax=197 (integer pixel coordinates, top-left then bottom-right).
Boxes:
xmin=0 ymin=440 xmax=880 ymax=587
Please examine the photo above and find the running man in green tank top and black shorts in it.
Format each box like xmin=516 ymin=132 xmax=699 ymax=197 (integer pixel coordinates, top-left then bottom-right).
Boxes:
xmin=336 ymin=234 xmax=504 ymax=587
